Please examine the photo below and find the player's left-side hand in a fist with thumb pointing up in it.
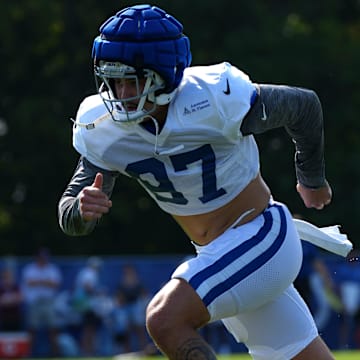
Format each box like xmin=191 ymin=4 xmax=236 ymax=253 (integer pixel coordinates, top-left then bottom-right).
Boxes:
xmin=78 ymin=173 xmax=112 ymax=221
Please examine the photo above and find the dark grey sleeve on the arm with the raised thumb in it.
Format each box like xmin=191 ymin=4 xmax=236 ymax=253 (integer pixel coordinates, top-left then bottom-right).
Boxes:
xmin=58 ymin=157 xmax=118 ymax=236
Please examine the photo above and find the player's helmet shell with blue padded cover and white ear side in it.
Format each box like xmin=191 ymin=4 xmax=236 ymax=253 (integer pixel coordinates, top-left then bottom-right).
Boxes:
xmin=92 ymin=5 xmax=191 ymax=124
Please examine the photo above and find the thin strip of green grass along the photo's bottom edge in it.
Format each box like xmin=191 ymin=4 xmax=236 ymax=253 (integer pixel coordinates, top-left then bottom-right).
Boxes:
xmin=28 ymin=351 xmax=360 ymax=360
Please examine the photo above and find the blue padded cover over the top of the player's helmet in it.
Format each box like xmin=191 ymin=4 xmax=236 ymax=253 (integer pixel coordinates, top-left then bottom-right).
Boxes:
xmin=92 ymin=5 xmax=191 ymax=93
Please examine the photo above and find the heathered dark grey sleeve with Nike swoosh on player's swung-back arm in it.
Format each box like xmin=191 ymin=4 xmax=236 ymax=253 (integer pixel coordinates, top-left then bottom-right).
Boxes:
xmin=241 ymin=84 xmax=326 ymax=188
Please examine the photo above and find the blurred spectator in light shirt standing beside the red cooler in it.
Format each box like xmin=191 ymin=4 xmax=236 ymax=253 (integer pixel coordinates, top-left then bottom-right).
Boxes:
xmin=22 ymin=248 xmax=62 ymax=356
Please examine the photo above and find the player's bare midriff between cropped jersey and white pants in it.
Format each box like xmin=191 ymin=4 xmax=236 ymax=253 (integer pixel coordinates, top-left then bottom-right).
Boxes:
xmin=173 ymin=174 xmax=270 ymax=245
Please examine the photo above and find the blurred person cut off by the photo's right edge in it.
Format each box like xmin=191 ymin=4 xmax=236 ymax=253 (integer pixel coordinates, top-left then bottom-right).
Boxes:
xmin=338 ymin=250 xmax=360 ymax=349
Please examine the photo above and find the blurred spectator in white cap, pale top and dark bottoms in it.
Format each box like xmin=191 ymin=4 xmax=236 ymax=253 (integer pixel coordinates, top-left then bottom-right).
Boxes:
xmin=74 ymin=256 xmax=102 ymax=356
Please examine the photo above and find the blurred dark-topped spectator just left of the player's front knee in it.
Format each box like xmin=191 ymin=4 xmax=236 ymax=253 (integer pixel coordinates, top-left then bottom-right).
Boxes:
xmin=118 ymin=264 xmax=150 ymax=351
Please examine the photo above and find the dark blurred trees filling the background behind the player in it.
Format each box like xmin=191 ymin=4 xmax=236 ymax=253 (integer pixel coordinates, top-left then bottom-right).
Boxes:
xmin=0 ymin=0 xmax=360 ymax=358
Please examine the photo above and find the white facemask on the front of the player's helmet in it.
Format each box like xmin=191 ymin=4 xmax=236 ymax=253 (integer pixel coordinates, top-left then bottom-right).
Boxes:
xmin=94 ymin=61 xmax=169 ymax=123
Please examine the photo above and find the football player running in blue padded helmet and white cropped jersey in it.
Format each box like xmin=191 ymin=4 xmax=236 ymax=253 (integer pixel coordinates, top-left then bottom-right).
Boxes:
xmin=59 ymin=5 xmax=333 ymax=360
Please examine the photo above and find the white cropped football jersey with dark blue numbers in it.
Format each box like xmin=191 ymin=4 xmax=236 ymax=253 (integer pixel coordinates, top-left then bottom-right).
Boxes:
xmin=73 ymin=63 xmax=259 ymax=215
